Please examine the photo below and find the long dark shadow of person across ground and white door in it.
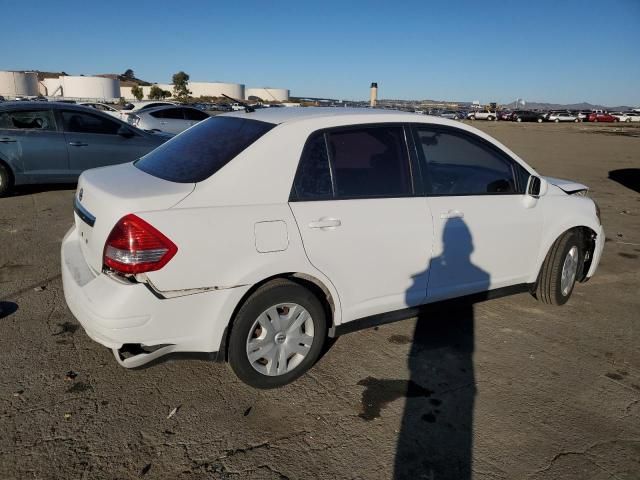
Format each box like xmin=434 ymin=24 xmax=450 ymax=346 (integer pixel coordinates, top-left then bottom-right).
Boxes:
xmin=394 ymin=218 xmax=490 ymax=480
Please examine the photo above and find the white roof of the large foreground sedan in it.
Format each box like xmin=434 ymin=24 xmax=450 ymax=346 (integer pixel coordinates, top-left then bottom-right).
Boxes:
xmin=225 ymin=107 xmax=449 ymax=125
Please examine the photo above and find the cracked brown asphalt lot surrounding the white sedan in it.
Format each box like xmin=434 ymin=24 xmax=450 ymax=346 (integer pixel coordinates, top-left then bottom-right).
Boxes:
xmin=0 ymin=121 xmax=640 ymax=480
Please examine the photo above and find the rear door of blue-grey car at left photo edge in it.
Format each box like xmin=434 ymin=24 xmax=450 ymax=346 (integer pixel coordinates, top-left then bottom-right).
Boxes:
xmin=0 ymin=108 xmax=71 ymax=183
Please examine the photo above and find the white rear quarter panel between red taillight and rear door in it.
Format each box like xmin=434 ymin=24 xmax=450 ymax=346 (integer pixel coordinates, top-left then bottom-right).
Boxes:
xmin=137 ymin=203 xmax=340 ymax=323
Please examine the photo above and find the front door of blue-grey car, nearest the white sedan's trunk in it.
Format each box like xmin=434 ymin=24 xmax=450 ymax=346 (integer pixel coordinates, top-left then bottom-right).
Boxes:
xmin=61 ymin=110 xmax=158 ymax=175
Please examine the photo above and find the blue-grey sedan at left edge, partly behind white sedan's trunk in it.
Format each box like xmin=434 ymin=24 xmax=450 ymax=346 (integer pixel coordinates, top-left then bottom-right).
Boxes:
xmin=0 ymin=102 xmax=169 ymax=196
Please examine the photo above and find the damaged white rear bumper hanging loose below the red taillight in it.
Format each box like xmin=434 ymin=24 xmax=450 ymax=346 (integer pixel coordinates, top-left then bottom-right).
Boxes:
xmin=61 ymin=227 xmax=249 ymax=366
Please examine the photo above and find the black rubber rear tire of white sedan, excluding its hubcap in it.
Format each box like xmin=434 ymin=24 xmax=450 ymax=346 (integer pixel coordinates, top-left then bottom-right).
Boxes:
xmin=228 ymin=282 xmax=327 ymax=389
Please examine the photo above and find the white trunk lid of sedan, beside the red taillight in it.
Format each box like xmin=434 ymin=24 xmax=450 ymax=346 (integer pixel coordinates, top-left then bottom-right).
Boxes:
xmin=74 ymin=163 xmax=195 ymax=272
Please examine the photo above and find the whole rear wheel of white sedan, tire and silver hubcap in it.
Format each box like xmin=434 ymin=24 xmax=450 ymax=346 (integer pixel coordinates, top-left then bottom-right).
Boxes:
xmin=228 ymin=279 xmax=327 ymax=389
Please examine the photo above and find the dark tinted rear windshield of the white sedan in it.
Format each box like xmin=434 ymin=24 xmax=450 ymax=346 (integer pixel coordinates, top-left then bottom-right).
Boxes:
xmin=135 ymin=117 xmax=275 ymax=183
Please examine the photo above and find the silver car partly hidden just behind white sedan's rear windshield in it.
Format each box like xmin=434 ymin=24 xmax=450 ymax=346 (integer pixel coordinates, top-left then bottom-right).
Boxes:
xmin=127 ymin=106 xmax=210 ymax=134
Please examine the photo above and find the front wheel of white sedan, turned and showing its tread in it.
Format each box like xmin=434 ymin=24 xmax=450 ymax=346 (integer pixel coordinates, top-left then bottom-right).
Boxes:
xmin=535 ymin=230 xmax=584 ymax=305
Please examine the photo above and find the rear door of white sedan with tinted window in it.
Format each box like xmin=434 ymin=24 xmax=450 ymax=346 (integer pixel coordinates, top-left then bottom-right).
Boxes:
xmin=290 ymin=124 xmax=433 ymax=321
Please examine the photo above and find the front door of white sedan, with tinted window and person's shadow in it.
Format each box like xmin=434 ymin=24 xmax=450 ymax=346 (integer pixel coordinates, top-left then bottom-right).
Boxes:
xmin=414 ymin=126 xmax=543 ymax=301
